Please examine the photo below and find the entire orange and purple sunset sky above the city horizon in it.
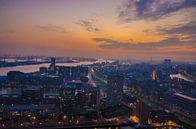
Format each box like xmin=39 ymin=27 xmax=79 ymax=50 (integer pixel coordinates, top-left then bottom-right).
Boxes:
xmin=0 ymin=0 xmax=196 ymax=62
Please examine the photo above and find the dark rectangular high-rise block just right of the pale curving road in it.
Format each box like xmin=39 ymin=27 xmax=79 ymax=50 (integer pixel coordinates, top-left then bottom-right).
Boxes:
xmin=107 ymin=75 xmax=124 ymax=103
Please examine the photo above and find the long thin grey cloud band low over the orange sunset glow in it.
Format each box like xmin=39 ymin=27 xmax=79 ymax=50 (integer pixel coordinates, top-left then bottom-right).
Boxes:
xmin=92 ymin=37 xmax=196 ymax=50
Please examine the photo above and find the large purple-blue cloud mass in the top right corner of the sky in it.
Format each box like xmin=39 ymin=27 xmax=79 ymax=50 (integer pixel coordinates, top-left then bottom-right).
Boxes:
xmin=118 ymin=0 xmax=196 ymax=22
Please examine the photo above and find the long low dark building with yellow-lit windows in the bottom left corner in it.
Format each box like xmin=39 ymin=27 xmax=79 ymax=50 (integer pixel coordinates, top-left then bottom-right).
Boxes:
xmin=0 ymin=104 xmax=55 ymax=122
